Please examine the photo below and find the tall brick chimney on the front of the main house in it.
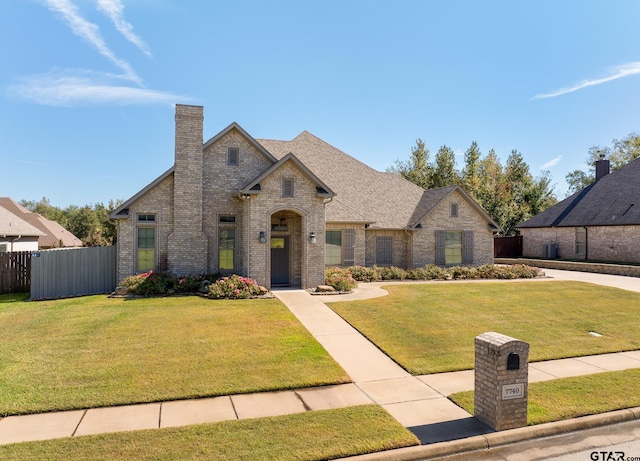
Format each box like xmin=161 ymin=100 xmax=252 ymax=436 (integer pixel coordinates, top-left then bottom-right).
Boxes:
xmin=167 ymin=104 xmax=208 ymax=275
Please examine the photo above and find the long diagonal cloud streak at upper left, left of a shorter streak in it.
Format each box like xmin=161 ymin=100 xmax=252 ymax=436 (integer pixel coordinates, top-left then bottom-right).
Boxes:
xmin=45 ymin=0 xmax=142 ymax=86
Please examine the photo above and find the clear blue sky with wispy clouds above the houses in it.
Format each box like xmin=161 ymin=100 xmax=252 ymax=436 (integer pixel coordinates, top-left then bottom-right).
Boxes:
xmin=0 ymin=0 xmax=640 ymax=208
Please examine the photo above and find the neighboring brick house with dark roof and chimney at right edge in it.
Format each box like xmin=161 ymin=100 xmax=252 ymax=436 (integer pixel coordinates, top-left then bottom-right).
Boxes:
xmin=518 ymin=158 xmax=640 ymax=263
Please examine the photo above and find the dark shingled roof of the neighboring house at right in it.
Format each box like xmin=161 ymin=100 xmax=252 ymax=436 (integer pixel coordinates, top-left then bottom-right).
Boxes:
xmin=518 ymin=158 xmax=640 ymax=228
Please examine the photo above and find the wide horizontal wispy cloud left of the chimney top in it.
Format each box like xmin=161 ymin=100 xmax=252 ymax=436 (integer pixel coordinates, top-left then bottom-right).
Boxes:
xmin=9 ymin=69 xmax=192 ymax=107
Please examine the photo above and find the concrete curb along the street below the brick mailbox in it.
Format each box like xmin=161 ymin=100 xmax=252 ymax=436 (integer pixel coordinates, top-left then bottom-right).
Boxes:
xmin=348 ymin=407 xmax=640 ymax=461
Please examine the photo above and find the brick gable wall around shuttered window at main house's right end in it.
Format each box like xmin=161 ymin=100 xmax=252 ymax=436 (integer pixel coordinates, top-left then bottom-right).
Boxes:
xmin=412 ymin=187 xmax=493 ymax=267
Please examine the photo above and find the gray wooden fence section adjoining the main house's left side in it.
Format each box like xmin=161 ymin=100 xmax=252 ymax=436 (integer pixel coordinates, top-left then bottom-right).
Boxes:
xmin=31 ymin=245 xmax=118 ymax=299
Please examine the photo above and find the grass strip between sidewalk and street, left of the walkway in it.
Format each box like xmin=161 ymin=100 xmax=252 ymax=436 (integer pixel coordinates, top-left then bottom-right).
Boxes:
xmin=0 ymin=405 xmax=419 ymax=461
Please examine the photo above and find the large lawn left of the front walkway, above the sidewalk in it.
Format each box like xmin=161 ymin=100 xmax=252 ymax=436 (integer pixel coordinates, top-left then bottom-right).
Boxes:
xmin=0 ymin=295 xmax=350 ymax=416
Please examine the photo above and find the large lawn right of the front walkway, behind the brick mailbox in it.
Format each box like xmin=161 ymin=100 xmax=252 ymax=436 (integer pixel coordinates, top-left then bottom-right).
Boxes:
xmin=330 ymin=281 xmax=640 ymax=374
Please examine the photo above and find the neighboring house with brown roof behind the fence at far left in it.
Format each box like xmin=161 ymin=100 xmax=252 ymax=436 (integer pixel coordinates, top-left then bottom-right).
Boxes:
xmin=0 ymin=197 xmax=82 ymax=251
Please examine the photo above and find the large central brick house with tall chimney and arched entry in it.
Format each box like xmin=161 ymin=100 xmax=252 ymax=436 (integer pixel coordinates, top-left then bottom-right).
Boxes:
xmin=110 ymin=105 xmax=498 ymax=288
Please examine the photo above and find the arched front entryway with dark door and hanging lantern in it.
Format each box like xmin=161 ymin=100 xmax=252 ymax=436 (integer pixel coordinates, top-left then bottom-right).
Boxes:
xmin=270 ymin=210 xmax=303 ymax=287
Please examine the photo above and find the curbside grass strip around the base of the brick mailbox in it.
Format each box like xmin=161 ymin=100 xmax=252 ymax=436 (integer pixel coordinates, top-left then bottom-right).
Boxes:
xmin=449 ymin=369 xmax=640 ymax=425
